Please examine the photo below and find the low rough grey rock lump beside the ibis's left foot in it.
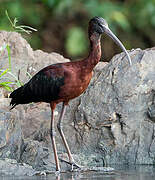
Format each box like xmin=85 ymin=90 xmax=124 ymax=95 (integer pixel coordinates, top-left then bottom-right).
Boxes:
xmin=20 ymin=139 xmax=55 ymax=172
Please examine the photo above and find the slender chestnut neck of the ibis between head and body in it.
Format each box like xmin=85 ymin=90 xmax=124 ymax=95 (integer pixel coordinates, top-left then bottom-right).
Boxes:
xmin=85 ymin=33 xmax=101 ymax=71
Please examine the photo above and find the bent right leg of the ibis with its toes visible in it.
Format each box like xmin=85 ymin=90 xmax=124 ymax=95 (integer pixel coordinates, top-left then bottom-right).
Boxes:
xmin=57 ymin=103 xmax=80 ymax=170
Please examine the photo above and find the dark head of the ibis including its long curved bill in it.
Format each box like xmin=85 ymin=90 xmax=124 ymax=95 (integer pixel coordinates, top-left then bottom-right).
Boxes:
xmin=89 ymin=17 xmax=132 ymax=65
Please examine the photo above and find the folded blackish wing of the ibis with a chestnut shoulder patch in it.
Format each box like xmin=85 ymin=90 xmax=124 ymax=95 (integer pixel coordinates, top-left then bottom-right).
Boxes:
xmin=10 ymin=65 xmax=64 ymax=105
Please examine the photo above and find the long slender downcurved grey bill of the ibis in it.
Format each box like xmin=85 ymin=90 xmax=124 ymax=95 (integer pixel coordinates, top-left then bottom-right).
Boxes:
xmin=104 ymin=27 xmax=132 ymax=66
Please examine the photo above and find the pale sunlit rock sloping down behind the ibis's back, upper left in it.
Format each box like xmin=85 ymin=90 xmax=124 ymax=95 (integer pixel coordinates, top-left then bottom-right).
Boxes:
xmin=0 ymin=31 xmax=69 ymax=83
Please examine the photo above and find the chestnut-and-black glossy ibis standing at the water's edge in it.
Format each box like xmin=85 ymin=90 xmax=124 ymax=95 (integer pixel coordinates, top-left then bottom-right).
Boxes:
xmin=10 ymin=16 xmax=132 ymax=172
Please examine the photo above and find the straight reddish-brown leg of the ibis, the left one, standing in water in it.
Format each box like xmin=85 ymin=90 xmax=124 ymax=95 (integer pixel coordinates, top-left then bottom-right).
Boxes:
xmin=50 ymin=104 xmax=60 ymax=172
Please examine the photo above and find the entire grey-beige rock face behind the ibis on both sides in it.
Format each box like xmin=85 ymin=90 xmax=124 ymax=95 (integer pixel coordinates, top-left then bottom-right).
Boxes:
xmin=0 ymin=32 xmax=155 ymax=175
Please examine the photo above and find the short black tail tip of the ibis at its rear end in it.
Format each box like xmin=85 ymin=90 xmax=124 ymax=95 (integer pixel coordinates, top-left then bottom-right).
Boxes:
xmin=10 ymin=86 xmax=24 ymax=110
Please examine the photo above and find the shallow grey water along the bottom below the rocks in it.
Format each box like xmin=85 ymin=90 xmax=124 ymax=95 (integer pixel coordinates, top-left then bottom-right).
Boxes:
xmin=0 ymin=166 xmax=155 ymax=180
